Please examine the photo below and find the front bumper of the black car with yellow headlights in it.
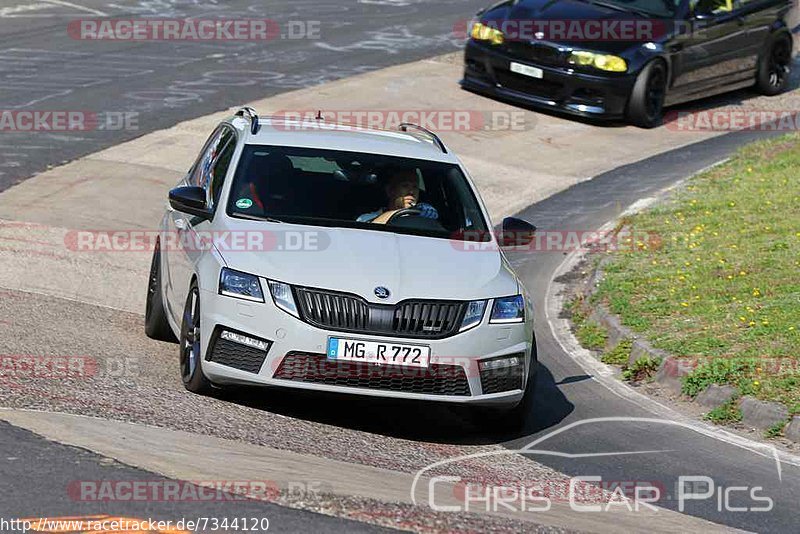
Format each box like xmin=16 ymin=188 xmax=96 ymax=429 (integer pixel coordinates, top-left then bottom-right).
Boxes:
xmin=459 ymin=41 xmax=636 ymax=119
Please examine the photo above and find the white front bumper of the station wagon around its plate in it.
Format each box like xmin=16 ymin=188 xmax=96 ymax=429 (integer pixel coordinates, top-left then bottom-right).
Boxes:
xmin=196 ymin=286 xmax=536 ymax=406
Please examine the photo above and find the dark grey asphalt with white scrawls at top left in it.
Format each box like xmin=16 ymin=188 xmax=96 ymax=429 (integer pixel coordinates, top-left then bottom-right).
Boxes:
xmin=0 ymin=0 xmax=485 ymax=191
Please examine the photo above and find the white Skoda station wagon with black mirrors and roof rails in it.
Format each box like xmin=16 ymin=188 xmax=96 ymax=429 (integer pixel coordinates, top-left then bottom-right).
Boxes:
xmin=145 ymin=108 xmax=537 ymax=432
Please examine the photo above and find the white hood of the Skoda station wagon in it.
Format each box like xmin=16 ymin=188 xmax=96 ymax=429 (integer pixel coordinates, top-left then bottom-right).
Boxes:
xmin=218 ymin=219 xmax=519 ymax=304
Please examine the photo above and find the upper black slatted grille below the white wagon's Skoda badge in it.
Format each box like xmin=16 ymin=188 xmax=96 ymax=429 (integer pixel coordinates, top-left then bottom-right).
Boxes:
xmin=295 ymin=287 xmax=467 ymax=339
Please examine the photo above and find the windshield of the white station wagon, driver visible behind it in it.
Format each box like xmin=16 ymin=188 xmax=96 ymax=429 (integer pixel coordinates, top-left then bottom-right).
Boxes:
xmin=227 ymin=145 xmax=487 ymax=239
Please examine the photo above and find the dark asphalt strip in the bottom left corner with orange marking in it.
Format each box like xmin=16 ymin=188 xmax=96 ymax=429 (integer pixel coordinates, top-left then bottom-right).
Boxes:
xmin=0 ymin=422 xmax=391 ymax=533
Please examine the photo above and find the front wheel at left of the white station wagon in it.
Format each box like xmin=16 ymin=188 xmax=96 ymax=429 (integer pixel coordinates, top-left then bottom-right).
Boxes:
xmin=179 ymin=281 xmax=213 ymax=395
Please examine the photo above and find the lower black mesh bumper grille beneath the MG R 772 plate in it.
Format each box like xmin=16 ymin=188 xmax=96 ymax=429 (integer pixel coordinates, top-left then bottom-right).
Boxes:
xmin=273 ymin=352 xmax=470 ymax=396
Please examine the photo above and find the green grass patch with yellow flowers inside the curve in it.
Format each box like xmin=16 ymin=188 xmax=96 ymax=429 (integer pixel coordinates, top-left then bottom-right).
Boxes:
xmin=597 ymin=134 xmax=800 ymax=413
